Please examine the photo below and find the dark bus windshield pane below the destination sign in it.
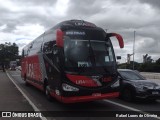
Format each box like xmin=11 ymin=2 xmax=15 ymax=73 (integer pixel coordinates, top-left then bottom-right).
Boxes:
xmin=64 ymin=39 xmax=114 ymax=68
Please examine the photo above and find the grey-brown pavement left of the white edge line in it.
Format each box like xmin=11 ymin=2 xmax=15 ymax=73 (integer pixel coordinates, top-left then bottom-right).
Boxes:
xmin=0 ymin=71 xmax=33 ymax=111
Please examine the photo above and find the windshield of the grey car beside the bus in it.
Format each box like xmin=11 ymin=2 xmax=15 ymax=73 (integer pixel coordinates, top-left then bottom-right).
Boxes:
xmin=119 ymin=71 xmax=145 ymax=80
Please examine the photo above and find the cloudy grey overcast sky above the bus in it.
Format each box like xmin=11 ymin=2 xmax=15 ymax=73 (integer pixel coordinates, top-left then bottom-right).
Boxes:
xmin=0 ymin=0 xmax=160 ymax=62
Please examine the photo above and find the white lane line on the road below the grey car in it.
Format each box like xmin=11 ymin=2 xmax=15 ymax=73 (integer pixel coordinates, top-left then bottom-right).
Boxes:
xmin=104 ymin=100 xmax=160 ymax=120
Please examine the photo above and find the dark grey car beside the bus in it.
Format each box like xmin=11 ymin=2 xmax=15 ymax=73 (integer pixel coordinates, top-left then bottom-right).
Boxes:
xmin=118 ymin=69 xmax=160 ymax=101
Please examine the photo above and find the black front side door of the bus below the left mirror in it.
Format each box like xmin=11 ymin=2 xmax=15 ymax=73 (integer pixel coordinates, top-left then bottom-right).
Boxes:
xmin=43 ymin=41 xmax=61 ymax=89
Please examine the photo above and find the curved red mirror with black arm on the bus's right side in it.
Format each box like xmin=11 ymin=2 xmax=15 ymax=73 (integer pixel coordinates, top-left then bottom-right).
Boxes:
xmin=107 ymin=33 xmax=124 ymax=48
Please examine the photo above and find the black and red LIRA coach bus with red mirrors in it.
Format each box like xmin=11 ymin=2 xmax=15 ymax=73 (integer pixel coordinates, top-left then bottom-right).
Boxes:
xmin=21 ymin=20 xmax=124 ymax=103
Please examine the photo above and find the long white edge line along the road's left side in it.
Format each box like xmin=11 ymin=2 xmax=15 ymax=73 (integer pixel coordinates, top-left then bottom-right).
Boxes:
xmin=6 ymin=72 xmax=47 ymax=120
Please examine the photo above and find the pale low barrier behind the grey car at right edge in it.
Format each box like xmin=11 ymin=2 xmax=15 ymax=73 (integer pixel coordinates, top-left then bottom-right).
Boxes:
xmin=140 ymin=72 xmax=160 ymax=79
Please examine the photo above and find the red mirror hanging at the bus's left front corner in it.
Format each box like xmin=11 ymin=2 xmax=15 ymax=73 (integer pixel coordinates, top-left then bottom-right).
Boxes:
xmin=56 ymin=29 xmax=63 ymax=47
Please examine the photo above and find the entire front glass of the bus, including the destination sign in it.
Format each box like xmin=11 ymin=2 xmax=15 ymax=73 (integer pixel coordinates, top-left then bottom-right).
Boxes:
xmin=64 ymin=30 xmax=116 ymax=74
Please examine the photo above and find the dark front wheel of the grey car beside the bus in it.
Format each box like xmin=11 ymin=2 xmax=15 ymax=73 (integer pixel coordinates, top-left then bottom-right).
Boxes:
xmin=122 ymin=88 xmax=135 ymax=102
